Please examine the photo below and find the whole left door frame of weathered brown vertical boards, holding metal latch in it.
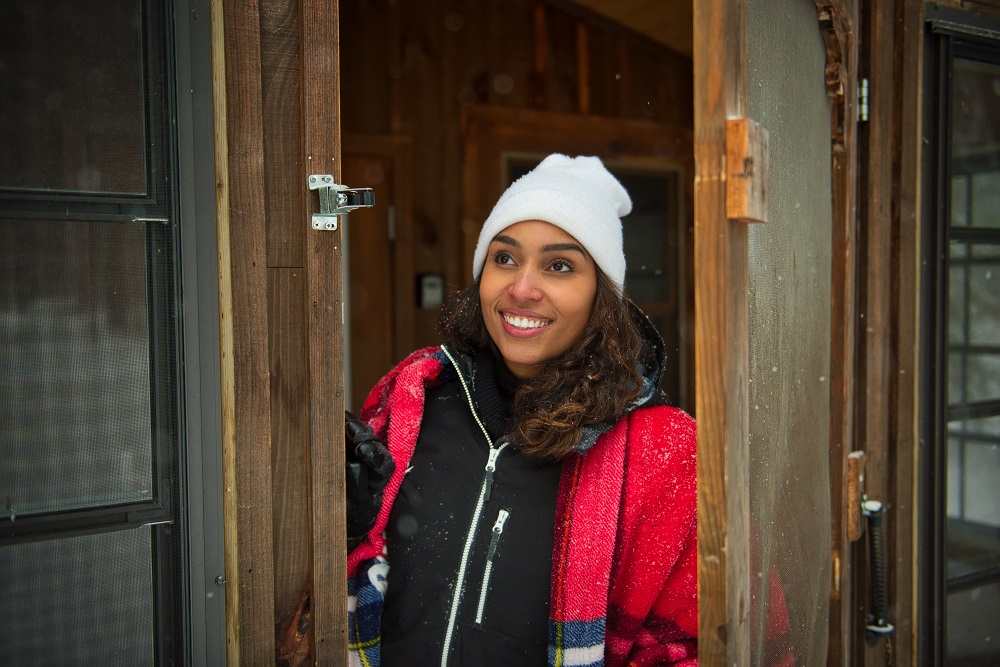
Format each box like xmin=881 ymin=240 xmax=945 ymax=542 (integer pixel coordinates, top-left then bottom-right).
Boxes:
xmin=209 ymin=0 xmax=347 ymax=665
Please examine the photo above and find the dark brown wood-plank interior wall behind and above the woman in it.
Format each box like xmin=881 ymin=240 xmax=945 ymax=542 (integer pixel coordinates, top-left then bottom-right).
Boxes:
xmin=341 ymin=0 xmax=693 ymax=350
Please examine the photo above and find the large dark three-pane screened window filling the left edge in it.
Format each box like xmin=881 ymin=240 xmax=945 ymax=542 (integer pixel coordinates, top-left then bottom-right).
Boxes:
xmin=0 ymin=0 xmax=187 ymax=665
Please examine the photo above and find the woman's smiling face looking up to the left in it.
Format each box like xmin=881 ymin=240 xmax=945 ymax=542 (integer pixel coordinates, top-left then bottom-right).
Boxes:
xmin=479 ymin=220 xmax=597 ymax=378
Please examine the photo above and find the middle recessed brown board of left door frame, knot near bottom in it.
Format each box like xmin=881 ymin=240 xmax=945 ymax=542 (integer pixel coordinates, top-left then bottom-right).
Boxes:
xmin=261 ymin=0 xmax=312 ymax=653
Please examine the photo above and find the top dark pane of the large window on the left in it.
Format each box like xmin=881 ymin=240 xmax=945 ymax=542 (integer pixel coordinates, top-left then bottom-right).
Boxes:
xmin=0 ymin=0 xmax=147 ymax=195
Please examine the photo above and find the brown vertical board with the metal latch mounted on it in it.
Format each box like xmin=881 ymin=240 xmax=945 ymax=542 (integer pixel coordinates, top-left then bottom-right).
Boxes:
xmin=301 ymin=0 xmax=347 ymax=665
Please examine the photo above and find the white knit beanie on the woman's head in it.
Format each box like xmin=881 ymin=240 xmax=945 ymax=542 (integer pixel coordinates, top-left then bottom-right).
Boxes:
xmin=472 ymin=153 xmax=632 ymax=293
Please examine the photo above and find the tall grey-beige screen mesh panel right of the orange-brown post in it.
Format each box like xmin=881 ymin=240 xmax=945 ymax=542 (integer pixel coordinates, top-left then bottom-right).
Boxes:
xmin=748 ymin=0 xmax=832 ymax=665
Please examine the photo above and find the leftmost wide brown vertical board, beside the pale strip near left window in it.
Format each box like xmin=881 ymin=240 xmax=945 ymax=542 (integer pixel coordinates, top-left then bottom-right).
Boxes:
xmin=215 ymin=0 xmax=274 ymax=664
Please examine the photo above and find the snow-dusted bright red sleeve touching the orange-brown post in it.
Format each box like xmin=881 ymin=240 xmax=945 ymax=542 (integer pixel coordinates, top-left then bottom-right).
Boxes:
xmin=606 ymin=407 xmax=698 ymax=667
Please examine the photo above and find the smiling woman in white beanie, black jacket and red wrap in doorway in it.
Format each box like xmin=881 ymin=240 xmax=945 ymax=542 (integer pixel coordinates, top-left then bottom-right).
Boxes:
xmin=348 ymin=155 xmax=698 ymax=665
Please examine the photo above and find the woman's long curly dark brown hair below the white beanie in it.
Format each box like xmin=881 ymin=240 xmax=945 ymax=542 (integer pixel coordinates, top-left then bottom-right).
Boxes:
xmin=438 ymin=271 xmax=652 ymax=461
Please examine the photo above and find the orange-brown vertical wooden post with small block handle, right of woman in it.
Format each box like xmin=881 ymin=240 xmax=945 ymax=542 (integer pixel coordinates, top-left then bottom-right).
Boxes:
xmin=694 ymin=0 xmax=751 ymax=667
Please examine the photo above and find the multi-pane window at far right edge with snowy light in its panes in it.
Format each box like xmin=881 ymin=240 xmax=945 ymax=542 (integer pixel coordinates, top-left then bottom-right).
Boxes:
xmin=939 ymin=57 xmax=1000 ymax=664
